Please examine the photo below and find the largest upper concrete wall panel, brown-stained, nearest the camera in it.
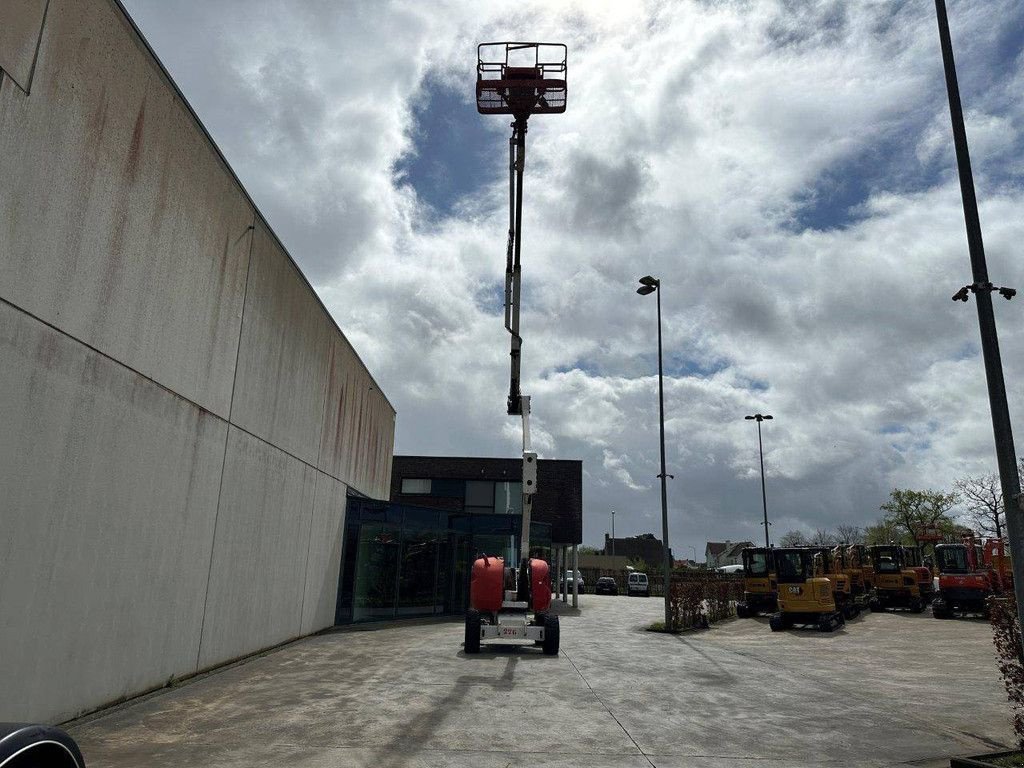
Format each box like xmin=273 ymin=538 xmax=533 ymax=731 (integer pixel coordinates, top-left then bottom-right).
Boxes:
xmin=0 ymin=0 xmax=254 ymax=418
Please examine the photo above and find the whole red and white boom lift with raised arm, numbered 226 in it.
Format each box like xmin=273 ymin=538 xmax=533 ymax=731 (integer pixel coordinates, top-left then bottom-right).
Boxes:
xmin=464 ymin=43 xmax=566 ymax=655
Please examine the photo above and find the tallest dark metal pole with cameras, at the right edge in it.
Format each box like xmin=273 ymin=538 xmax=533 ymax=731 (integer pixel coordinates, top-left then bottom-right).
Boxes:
xmin=935 ymin=0 xmax=1024 ymax=627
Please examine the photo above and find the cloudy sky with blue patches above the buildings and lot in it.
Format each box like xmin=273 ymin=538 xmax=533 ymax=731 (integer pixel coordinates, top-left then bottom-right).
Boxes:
xmin=123 ymin=0 xmax=1024 ymax=557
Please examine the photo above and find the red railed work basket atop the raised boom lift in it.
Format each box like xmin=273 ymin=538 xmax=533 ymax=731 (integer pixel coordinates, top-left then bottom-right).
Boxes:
xmin=476 ymin=43 xmax=566 ymax=117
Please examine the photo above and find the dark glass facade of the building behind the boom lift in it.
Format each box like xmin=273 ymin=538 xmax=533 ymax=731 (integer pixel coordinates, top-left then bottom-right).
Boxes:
xmin=335 ymin=499 xmax=551 ymax=624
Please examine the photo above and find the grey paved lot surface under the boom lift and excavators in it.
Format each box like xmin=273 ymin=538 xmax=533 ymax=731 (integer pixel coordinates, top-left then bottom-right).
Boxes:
xmin=67 ymin=595 xmax=1012 ymax=768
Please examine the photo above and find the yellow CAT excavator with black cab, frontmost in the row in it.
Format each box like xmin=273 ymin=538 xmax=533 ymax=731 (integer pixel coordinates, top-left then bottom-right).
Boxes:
xmin=768 ymin=547 xmax=846 ymax=632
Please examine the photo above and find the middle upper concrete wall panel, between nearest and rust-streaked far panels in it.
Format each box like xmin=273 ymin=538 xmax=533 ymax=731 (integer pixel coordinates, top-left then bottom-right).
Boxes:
xmin=231 ymin=224 xmax=329 ymax=466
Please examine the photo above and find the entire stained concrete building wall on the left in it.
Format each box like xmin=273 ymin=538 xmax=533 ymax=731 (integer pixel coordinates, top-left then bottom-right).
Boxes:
xmin=0 ymin=0 xmax=394 ymax=722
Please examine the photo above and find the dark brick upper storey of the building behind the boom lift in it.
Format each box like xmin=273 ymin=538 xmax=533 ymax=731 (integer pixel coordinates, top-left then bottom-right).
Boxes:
xmin=391 ymin=456 xmax=583 ymax=545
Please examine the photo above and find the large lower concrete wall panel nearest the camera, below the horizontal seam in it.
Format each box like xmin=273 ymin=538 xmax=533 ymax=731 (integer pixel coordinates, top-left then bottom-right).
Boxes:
xmin=0 ymin=302 xmax=227 ymax=722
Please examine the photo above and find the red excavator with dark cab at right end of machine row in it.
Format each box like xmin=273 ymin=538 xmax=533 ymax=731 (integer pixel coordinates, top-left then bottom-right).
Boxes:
xmin=932 ymin=536 xmax=1013 ymax=618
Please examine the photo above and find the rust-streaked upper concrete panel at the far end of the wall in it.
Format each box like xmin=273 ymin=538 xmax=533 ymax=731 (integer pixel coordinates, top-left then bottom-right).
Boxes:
xmin=319 ymin=336 xmax=394 ymax=499
